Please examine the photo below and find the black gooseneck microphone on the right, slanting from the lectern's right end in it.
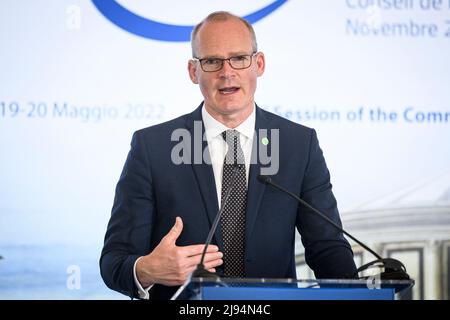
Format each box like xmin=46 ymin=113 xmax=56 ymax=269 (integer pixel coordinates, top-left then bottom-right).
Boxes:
xmin=258 ymin=175 xmax=409 ymax=280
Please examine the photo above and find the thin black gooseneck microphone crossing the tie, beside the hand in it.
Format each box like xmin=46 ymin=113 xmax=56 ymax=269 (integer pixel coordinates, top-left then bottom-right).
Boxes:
xmin=192 ymin=164 xmax=240 ymax=279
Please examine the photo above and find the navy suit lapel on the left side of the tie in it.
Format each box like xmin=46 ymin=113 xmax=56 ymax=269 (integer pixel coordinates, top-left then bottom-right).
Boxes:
xmin=186 ymin=103 xmax=223 ymax=251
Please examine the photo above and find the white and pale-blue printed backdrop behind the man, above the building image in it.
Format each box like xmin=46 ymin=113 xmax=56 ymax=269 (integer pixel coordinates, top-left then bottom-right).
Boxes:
xmin=0 ymin=0 xmax=450 ymax=299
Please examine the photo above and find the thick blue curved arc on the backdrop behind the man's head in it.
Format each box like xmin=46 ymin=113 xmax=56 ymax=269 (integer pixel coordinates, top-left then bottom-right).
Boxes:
xmin=92 ymin=0 xmax=287 ymax=42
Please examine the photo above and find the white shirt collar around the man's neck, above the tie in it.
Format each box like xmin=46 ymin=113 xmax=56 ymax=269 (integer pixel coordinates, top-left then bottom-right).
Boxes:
xmin=202 ymin=106 xmax=256 ymax=142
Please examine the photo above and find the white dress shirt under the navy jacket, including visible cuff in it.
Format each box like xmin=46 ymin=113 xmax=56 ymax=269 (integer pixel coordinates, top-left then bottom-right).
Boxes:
xmin=133 ymin=107 xmax=256 ymax=299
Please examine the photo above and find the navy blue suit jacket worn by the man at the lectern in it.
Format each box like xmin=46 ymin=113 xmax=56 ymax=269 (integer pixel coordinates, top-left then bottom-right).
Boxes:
xmin=100 ymin=105 xmax=356 ymax=299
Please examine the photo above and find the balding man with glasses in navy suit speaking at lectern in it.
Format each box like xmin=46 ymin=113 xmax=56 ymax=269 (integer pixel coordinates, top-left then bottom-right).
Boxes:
xmin=100 ymin=12 xmax=356 ymax=299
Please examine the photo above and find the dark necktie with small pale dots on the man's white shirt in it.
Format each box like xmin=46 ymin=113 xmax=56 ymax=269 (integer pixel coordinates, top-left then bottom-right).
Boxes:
xmin=221 ymin=130 xmax=247 ymax=277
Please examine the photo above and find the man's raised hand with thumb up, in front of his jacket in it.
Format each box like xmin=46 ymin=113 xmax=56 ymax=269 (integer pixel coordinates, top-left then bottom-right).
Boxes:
xmin=136 ymin=217 xmax=223 ymax=288
